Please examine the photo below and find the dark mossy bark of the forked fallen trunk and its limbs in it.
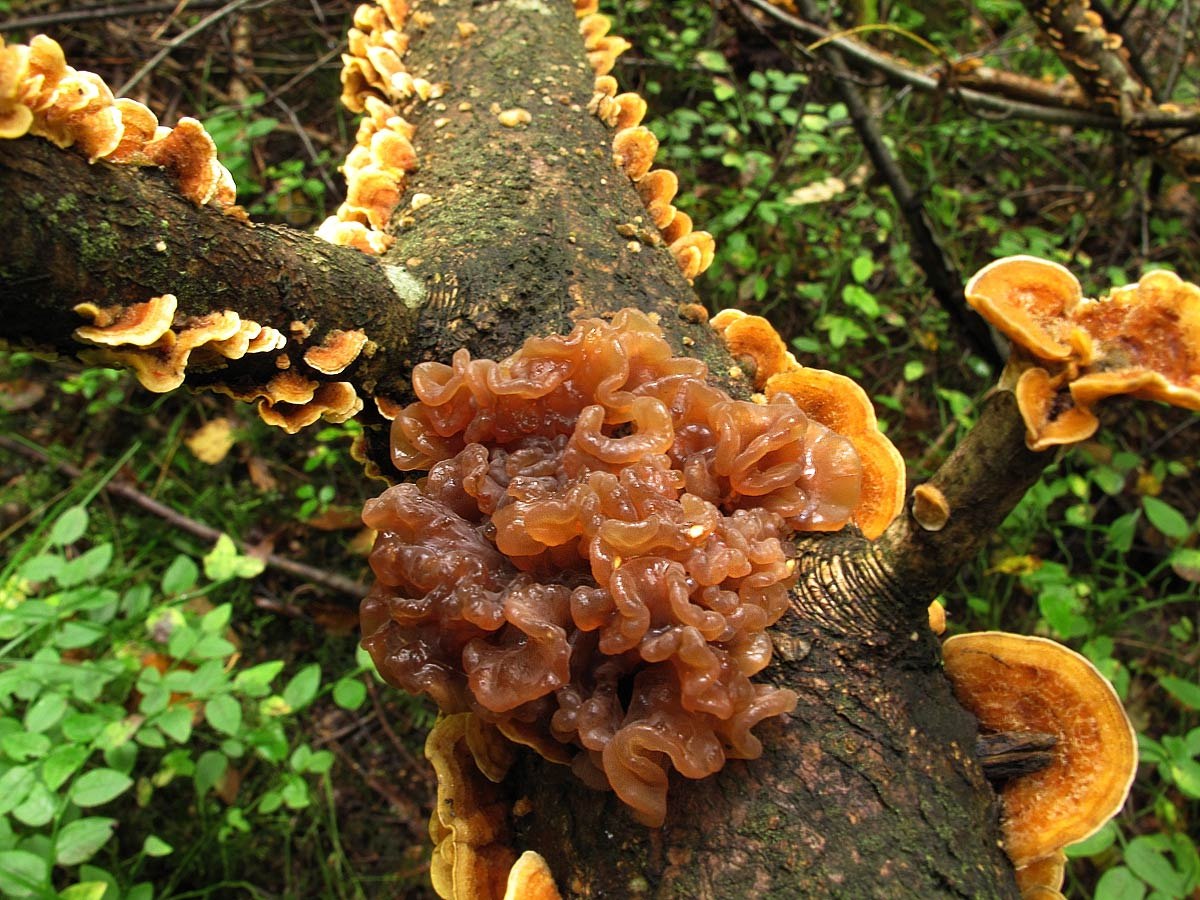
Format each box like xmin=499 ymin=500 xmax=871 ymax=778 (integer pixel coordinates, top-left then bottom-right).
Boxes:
xmin=0 ymin=0 xmax=1065 ymax=898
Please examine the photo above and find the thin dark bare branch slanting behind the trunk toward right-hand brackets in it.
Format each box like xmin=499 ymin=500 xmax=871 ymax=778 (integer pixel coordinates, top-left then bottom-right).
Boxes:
xmin=777 ymin=0 xmax=1004 ymax=371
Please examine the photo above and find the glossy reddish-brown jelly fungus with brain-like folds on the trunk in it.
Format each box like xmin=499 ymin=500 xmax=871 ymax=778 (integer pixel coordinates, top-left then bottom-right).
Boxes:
xmin=361 ymin=310 xmax=862 ymax=824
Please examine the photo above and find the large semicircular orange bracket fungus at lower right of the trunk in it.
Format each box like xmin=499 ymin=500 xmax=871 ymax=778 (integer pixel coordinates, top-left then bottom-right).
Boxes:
xmin=942 ymin=631 xmax=1138 ymax=873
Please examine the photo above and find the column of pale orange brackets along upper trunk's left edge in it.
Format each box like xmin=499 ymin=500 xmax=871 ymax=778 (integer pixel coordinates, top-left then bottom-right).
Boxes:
xmin=317 ymin=0 xmax=440 ymax=253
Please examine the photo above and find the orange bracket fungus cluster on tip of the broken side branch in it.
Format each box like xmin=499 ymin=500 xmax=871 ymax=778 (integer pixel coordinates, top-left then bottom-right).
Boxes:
xmin=966 ymin=257 xmax=1200 ymax=450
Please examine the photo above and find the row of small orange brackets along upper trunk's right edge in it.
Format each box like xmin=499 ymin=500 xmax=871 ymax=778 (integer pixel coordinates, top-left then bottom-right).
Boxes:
xmin=575 ymin=0 xmax=716 ymax=281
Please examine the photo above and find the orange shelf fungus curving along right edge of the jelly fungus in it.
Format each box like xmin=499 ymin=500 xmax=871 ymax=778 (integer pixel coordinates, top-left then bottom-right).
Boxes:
xmin=709 ymin=310 xmax=905 ymax=540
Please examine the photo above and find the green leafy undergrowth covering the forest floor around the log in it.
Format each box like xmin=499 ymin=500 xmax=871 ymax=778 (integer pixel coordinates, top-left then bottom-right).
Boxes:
xmin=0 ymin=0 xmax=1200 ymax=900
